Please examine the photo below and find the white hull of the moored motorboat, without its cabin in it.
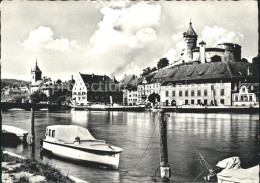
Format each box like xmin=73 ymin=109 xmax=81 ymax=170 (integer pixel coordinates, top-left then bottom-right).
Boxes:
xmin=42 ymin=140 xmax=120 ymax=169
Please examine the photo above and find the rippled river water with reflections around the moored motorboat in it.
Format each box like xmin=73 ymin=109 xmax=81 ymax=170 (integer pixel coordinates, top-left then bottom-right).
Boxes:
xmin=3 ymin=110 xmax=259 ymax=182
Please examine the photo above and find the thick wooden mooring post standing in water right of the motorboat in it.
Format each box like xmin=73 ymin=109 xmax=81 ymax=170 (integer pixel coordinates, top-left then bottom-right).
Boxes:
xmin=159 ymin=110 xmax=171 ymax=180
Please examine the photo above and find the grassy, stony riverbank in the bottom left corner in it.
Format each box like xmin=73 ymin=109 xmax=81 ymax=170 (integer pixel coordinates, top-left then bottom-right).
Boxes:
xmin=2 ymin=151 xmax=87 ymax=183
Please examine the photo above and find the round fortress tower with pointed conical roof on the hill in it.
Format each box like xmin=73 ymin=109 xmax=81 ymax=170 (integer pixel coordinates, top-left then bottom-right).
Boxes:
xmin=183 ymin=21 xmax=198 ymax=63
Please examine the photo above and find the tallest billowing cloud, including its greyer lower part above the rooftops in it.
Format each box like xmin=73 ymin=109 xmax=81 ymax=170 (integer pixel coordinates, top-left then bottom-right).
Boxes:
xmin=90 ymin=2 xmax=161 ymax=74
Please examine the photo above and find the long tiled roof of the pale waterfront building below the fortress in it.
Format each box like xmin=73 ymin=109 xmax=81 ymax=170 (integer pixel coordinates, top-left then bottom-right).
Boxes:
xmin=163 ymin=61 xmax=259 ymax=84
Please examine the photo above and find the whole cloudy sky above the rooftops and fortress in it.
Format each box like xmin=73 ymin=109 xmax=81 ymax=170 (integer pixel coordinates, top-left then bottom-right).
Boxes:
xmin=1 ymin=1 xmax=258 ymax=80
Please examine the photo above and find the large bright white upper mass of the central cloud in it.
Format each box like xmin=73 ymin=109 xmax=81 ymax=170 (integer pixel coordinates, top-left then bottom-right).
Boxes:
xmin=90 ymin=2 xmax=161 ymax=53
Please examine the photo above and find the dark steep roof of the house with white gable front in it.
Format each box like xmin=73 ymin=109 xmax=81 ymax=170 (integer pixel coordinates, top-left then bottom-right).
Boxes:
xmin=80 ymin=73 xmax=120 ymax=92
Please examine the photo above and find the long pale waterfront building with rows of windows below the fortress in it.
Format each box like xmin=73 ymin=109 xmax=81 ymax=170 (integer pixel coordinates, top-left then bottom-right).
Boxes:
xmin=161 ymin=61 xmax=259 ymax=106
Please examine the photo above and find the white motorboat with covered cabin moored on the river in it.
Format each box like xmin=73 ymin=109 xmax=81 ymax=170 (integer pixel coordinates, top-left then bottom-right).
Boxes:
xmin=41 ymin=125 xmax=123 ymax=169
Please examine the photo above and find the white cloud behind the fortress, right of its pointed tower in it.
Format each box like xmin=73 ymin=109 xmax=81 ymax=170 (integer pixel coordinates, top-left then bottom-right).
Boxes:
xmin=201 ymin=26 xmax=244 ymax=46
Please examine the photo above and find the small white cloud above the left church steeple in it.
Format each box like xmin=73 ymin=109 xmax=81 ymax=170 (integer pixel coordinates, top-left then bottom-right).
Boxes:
xmin=23 ymin=26 xmax=77 ymax=51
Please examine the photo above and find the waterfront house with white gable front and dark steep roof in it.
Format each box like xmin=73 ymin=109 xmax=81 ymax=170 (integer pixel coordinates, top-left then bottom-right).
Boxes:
xmin=72 ymin=73 xmax=123 ymax=104
